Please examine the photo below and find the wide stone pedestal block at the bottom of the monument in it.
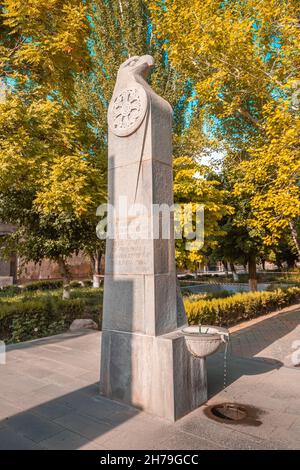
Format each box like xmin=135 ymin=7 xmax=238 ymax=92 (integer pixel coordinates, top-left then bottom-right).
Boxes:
xmin=100 ymin=330 xmax=207 ymax=421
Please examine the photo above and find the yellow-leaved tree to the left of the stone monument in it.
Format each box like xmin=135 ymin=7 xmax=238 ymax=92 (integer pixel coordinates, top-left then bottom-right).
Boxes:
xmin=0 ymin=0 xmax=105 ymax=297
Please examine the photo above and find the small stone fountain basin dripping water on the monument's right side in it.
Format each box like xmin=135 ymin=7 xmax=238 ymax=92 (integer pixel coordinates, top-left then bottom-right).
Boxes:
xmin=181 ymin=325 xmax=229 ymax=358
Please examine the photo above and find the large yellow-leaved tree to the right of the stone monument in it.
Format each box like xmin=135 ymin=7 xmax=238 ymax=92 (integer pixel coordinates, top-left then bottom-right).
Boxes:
xmin=148 ymin=0 xmax=300 ymax=280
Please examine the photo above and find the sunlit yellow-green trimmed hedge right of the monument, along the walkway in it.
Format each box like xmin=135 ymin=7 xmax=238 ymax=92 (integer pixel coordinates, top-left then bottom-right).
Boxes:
xmin=184 ymin=287 xmax=300 ymax=327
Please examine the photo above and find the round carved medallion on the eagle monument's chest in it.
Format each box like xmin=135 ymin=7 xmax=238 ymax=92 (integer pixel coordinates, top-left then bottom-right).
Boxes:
xmin=108 ymin=83 xmax=148 ymax=136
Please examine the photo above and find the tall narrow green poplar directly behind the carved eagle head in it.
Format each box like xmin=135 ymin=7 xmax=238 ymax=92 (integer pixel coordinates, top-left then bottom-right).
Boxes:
xmin=77 ymin=0 xmax=193 ymax=152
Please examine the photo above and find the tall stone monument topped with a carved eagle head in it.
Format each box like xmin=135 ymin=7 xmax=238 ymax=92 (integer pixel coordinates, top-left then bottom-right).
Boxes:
xmin=100 ymin=55 xmax=207 ymax=421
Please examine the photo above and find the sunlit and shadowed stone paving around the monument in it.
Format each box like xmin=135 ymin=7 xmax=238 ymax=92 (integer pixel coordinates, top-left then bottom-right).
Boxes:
xmin=0 ymin=308 xmax=300 ymax=450
